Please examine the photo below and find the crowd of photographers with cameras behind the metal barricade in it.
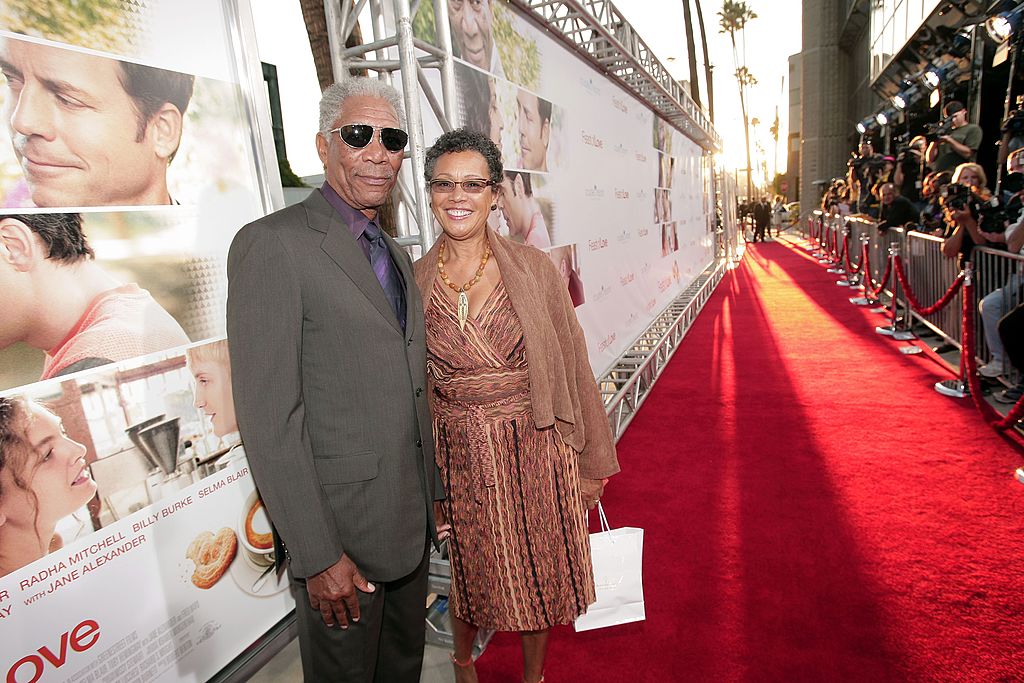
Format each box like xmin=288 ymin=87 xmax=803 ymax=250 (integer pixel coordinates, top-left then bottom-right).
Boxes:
xmin=821 ymin=100 xmax=1024 ymax=403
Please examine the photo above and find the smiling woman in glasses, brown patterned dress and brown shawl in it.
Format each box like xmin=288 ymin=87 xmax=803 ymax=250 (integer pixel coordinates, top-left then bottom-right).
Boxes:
xmin=416 ymin=129 xmax=618 ymax=683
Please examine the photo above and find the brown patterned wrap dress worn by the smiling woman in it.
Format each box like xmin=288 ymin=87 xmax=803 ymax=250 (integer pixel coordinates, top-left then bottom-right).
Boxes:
xmin=426 ymin=281 xmax=594 ymax=631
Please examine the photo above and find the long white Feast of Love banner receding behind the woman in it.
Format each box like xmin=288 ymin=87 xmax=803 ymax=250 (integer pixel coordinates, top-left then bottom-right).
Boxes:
xmin=413 ymin=0 xmax=715 ymax=375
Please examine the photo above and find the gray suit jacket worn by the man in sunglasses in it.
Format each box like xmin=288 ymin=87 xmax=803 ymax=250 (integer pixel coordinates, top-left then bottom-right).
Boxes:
xmin=227 ymin=190 xmax=441 ymax=581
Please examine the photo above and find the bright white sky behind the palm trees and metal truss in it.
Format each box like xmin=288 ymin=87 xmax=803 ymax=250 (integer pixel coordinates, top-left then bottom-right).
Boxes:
xmin=250 ymin=0 xmax=801 ymax=179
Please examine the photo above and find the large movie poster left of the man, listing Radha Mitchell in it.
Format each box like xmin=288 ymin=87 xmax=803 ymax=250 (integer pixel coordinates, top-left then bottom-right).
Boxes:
xmin=0 ymin=0 xmax=294 ymax=683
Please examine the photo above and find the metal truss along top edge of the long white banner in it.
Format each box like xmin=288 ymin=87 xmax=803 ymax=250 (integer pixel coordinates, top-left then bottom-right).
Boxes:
xmin=509 ymin=0 xmax=722 ymax=152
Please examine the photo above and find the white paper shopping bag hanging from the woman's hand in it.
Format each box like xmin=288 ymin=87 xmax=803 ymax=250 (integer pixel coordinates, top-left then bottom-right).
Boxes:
xmin=575 ymin=503 xmax=646 ymax=631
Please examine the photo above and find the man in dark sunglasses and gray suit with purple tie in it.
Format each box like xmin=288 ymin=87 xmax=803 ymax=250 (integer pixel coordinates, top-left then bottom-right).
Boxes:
xmin=227 ymin=78 xmax=441 ymax=682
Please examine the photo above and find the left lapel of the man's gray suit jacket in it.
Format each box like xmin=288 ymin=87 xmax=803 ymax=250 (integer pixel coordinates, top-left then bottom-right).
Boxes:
xmin=303 ymin=189 xmax=408 ymax=333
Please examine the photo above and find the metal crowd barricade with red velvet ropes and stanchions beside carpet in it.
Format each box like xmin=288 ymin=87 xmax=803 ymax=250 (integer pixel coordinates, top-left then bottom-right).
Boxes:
xmin=802 ymin=216 xmax=1024 ymax=429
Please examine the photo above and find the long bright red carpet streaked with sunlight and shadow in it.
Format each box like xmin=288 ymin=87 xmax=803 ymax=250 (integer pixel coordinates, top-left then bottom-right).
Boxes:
xmin=477 ymin=244 xmax=1024 ymax=683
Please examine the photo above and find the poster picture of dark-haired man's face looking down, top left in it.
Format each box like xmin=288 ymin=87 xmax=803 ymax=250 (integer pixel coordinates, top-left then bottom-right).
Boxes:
xmin=0 ymin=37 xmax=195 ymax=207
